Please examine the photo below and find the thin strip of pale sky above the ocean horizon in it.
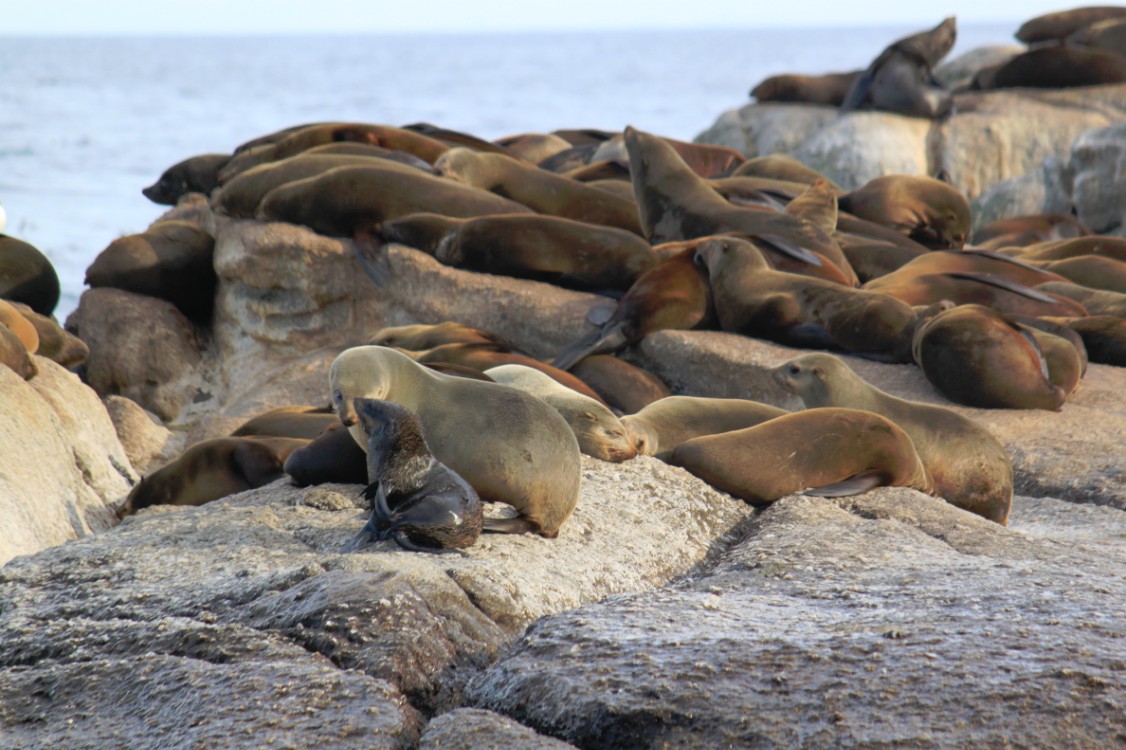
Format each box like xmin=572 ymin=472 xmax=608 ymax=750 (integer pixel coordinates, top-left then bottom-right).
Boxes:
xmin=0 ymin=0 xmax=1089 ymax=36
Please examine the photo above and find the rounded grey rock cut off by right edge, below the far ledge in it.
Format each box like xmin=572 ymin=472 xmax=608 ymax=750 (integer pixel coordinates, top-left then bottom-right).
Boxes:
xmin=1070 ymin=123 xmax=1126 ymax=234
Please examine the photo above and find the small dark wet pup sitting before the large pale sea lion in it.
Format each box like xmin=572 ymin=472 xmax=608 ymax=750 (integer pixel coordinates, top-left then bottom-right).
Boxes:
xmin=342 ymin=399 xmax=483 ymax=552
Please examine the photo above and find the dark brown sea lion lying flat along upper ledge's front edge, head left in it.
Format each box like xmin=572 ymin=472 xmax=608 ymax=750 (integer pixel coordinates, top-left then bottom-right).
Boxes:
xmin=379 ymin=214 xmax=658 ymax=292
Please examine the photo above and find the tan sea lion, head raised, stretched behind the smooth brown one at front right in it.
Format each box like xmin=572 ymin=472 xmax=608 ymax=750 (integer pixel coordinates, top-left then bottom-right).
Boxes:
xmin=774 ymin=352 xmax=1012 ymax=525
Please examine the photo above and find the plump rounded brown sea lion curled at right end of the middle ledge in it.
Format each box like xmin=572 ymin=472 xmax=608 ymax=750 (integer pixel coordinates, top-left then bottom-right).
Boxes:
xmin=913 ymin=305 xmax=1079 ymax=411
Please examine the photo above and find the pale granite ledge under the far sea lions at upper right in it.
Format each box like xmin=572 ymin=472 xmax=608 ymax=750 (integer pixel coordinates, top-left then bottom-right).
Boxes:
xmin=696 ymin=84 xmax=1126 ymax=198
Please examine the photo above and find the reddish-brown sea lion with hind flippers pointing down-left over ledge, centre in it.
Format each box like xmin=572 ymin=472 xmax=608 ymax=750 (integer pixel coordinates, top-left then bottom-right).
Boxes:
xmin=552 ymin=241 xmax=715 ymax=369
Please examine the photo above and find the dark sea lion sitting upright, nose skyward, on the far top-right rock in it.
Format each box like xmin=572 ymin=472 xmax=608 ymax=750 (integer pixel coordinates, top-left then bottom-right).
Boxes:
xmin=840 ymin=16 xmax=957 ymax=119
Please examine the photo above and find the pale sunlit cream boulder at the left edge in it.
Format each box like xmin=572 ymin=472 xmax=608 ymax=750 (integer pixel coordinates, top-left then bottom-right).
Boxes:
xmin=0 ymin=357 xmax=137 ymax=563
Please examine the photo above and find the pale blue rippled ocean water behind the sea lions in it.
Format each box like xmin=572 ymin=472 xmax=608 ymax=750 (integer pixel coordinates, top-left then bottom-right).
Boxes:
xmin=0 ymin=19 xmax=1018 ymax=320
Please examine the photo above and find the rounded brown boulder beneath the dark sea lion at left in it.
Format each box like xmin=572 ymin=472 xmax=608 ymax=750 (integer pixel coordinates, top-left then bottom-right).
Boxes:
xmin=66 ymin=288 xmax=200 ymax=421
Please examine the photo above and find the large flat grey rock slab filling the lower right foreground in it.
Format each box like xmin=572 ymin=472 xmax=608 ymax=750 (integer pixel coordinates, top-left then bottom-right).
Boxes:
xmin=468 ymin=489 xmax=1126 ymax=748
